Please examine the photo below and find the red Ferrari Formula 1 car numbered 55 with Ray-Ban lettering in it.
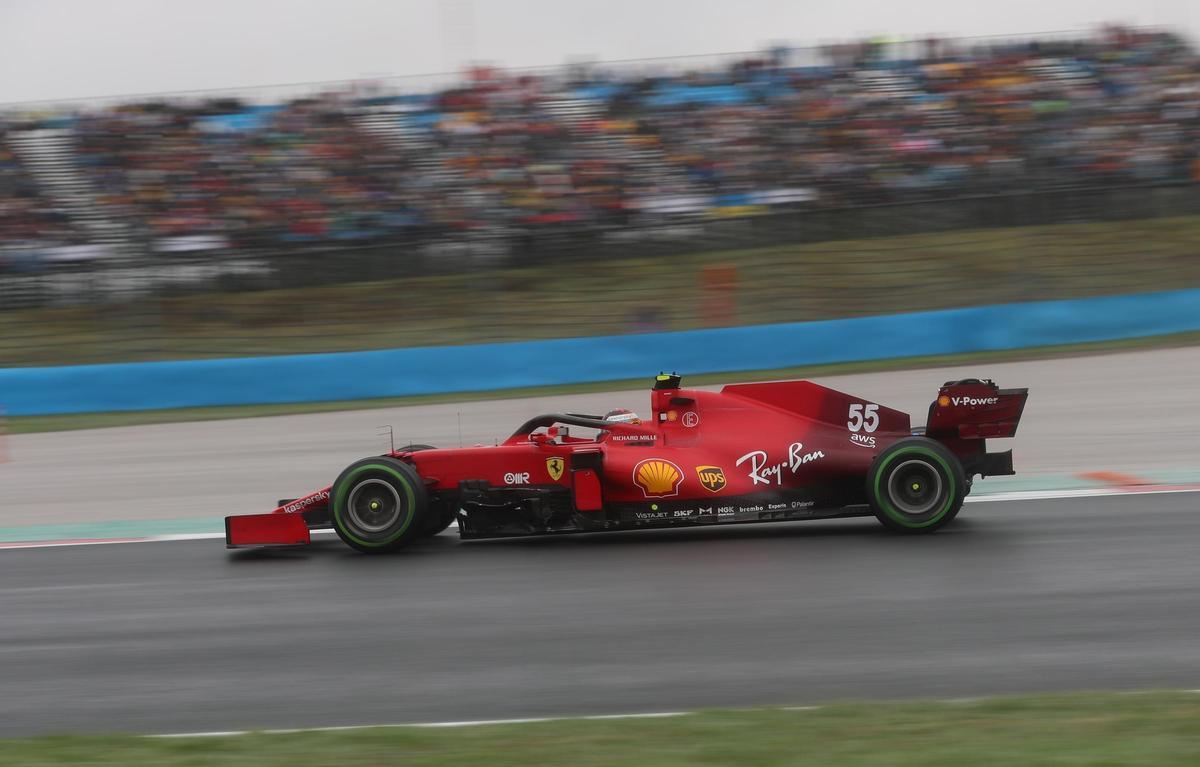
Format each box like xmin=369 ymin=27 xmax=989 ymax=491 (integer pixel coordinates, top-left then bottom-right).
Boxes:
xmin=226 ymin=374 xmax=1028 ymax=552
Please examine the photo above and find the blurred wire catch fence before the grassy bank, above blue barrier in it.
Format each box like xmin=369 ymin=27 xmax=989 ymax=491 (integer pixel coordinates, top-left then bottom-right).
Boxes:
xmin=0 ymin=184 xmax=1200 ymax=367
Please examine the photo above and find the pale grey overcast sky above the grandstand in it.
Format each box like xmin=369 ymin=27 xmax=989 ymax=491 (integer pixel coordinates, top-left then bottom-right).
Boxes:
xmin=0 ymin=0 xmax=1200 ymax=103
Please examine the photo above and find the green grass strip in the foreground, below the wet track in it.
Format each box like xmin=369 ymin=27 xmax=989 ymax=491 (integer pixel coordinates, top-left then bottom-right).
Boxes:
xmin=7 ymin=693 xmax=1200 ymax=767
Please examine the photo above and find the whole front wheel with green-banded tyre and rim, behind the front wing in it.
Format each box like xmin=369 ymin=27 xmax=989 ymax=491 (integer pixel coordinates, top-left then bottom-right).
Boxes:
xmin=329 ymin=456 xmax=430 ymax=553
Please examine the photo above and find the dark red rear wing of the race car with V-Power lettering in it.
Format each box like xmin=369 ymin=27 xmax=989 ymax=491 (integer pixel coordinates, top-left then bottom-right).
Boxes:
xmin=925 ymin=378 xmax=1030 ymax=439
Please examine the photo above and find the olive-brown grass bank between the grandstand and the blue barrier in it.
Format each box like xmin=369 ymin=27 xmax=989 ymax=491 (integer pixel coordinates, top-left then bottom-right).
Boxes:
xmin=7 ymin=210 xmax=1200 ymax=366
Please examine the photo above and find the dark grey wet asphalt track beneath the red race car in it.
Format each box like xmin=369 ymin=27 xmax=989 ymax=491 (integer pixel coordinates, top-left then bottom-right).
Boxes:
xmin=0 ymin=493 xmax=1200 ymax=736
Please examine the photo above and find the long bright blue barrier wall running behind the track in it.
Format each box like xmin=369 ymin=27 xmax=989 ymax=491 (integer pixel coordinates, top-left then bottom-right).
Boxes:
xmin=0 ymin=289 xmax=1200 ymax=415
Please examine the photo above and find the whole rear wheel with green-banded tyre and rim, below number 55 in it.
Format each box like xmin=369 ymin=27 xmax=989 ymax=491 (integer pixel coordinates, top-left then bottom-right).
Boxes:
xmin=866 ymin=437 xmax=967 ymax=533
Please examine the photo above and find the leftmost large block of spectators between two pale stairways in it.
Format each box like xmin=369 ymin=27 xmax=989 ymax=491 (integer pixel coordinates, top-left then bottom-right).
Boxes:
xmin=76 ymin=95 xmax=415 ymax=252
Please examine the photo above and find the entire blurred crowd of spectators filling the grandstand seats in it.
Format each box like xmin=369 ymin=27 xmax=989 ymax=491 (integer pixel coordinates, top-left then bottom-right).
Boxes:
xmin=0 ymin=29 xmax=1200 ymax=250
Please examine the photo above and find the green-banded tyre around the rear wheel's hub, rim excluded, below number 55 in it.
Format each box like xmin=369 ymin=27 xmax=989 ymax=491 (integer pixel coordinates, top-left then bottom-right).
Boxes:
xmin=866 ymin=437 xmax=966 ymax=533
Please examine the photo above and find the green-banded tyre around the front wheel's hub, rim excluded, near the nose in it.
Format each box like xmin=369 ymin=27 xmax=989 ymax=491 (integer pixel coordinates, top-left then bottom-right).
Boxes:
xmin=329 ymin=457 xmax=428 ymax=552
